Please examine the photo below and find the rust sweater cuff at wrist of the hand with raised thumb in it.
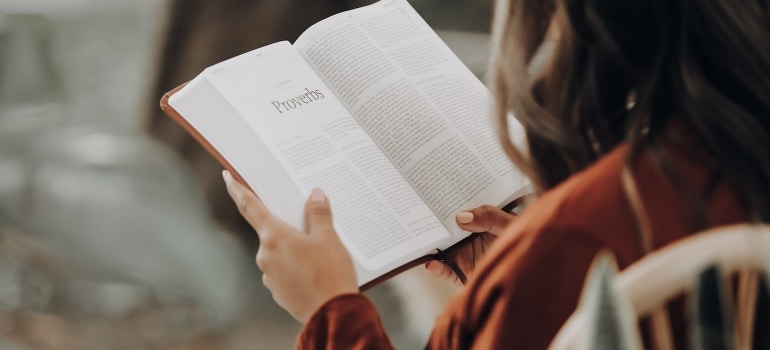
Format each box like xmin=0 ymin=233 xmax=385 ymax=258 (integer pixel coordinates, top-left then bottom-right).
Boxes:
xmin=297 ymin=293 xmax=393 ymax=349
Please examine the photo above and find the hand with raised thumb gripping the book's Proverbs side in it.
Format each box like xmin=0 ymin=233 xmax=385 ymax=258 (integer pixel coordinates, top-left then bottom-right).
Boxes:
xmin=222 ymin=170 xmax=359 ymax=323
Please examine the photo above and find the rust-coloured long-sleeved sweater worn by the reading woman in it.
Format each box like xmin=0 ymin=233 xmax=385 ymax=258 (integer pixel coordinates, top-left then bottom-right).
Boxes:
xmin=298 ymin=141 xmax=745 ymax=349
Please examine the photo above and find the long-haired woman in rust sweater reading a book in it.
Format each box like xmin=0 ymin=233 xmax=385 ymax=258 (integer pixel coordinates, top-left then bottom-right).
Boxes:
xmin=220 ymin=0 xmax=770 ymax=349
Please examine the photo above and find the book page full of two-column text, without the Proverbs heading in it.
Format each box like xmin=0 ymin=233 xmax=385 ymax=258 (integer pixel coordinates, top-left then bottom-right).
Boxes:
xmin=294 ymin=0 xmax=530 ymax=235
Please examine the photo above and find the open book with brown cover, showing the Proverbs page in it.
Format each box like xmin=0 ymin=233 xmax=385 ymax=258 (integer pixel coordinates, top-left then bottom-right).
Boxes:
xmin=161 ymin=0 xmax=530 ymax=289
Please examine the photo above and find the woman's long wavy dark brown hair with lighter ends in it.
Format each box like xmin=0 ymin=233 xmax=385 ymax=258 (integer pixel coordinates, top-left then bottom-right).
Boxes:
xmin=491 ymin=0 xmax=770 ymax=222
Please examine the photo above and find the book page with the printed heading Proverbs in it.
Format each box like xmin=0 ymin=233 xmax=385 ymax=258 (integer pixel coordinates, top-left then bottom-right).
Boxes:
xmin=195 ymin=43 xmax=450 ymax=271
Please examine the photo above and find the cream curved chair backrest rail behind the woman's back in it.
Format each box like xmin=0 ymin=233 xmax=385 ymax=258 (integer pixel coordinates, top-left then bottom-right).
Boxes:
xmin=550 ymin=224 xmax=770 ymax=350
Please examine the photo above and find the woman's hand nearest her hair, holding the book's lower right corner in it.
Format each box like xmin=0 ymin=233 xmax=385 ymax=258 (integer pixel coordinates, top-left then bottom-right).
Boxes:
xmin=425 ymin=205 xmax=516 ymax=285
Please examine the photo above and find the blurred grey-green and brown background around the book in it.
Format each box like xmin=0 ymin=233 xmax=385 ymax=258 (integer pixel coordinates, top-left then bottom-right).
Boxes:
xmin=0 ymin=0 xmax=492 ymax=350
